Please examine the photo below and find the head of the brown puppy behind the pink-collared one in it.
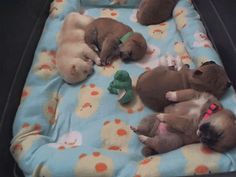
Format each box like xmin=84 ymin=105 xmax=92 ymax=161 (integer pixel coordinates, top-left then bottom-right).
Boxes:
xmin=190 ymin=61 xmax=231 ymax=98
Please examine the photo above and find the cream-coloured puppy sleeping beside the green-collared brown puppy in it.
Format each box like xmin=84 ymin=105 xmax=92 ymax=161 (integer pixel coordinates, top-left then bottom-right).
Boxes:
xmin=56 ymin=12 xmax=100 ymax=84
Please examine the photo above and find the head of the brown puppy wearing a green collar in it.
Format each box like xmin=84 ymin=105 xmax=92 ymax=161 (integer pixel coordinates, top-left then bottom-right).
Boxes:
xmin=120 ymin=33 xmax=147 ymax=61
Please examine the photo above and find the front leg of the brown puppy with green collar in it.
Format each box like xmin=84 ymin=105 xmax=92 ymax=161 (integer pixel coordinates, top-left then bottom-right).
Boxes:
xmin=100 ymin=36 xmax=119 ymax=65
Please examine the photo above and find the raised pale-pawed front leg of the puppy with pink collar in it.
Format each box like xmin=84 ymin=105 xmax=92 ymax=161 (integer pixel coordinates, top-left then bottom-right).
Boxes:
xmin=166 ymin=89 xmax=201 ymax=102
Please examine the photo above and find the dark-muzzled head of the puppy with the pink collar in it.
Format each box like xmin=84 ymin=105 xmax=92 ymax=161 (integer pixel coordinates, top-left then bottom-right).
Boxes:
xmin=197 ymin=109 xmax=236 ymax=152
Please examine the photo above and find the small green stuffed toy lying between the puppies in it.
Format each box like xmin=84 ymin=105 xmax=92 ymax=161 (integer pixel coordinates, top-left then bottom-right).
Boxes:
xmin=108 ymin=70 xmax=134 ymax=104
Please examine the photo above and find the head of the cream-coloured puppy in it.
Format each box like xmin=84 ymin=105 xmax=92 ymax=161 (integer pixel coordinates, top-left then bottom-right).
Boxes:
xmin=59 ymin=59 xmax=93 ymax=84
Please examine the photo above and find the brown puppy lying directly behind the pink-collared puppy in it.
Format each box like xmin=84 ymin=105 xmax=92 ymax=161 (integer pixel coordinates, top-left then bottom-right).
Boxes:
xmin=136 ymin=61 xmax=231 ymax=112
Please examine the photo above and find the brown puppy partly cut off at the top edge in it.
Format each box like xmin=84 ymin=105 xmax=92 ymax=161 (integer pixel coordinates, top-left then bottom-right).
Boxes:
xmin=137 ymin=0 xmax=178 ymax=25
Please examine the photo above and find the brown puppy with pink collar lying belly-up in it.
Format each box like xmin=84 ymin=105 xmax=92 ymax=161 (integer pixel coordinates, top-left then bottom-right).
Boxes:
xmin=131 ymin=89 xmax=236 ymax=156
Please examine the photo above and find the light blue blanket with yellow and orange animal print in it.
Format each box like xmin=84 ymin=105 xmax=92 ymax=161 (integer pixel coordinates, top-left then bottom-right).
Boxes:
xmin=11 ymin=0 xmax=236 ymax=177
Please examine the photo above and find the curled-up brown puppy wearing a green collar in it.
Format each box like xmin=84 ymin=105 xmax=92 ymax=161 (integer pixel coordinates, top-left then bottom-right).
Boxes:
xmin=85 ymin=18 xmax=147 ymax=65
